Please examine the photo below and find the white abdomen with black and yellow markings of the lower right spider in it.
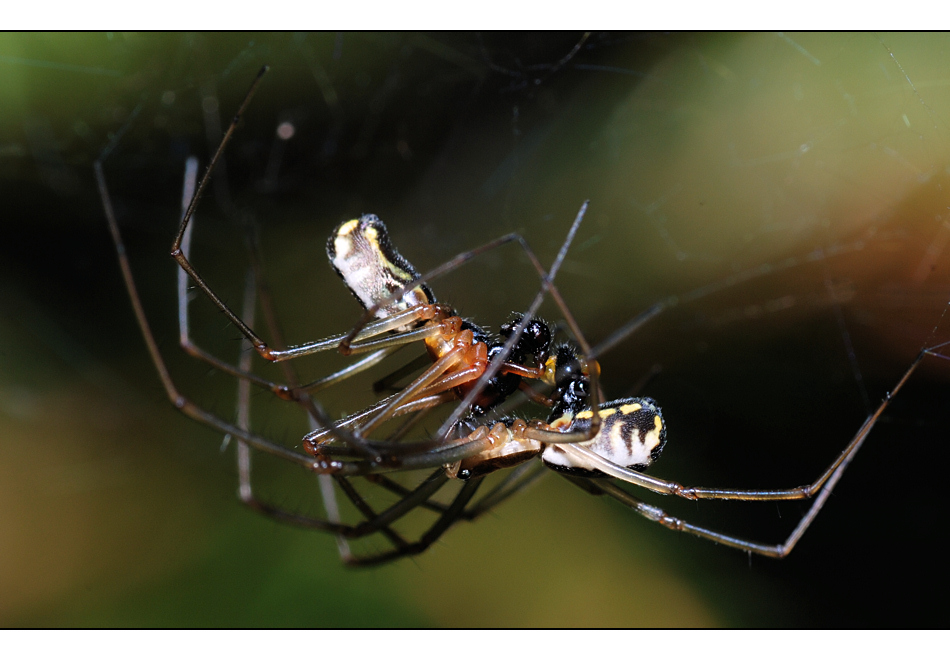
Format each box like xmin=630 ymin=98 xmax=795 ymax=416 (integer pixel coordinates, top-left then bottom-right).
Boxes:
xmin=541 ymin=398 xmax=666 ymax=477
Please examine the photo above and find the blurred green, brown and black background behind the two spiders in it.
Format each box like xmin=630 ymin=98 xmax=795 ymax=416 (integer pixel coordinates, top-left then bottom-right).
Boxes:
xmin=0 ymin=33 xmax=950 ymax=627
